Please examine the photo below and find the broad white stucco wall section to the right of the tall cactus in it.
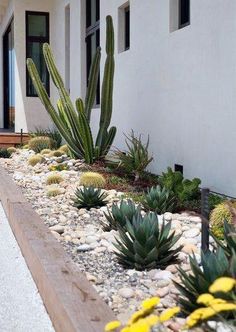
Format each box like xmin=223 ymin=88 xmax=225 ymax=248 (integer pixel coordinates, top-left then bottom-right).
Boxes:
xmin=98 ymin=0 xmax=236 ymax=196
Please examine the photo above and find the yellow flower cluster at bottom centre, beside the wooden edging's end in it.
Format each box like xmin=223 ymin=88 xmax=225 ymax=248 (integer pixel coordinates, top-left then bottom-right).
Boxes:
xmin=105 ymin=297 xmax=180 ymax=332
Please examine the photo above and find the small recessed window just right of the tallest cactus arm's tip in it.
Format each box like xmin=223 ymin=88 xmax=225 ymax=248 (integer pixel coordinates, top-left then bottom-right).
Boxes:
xmin=118 ymin=2 xmax=130 ymax=52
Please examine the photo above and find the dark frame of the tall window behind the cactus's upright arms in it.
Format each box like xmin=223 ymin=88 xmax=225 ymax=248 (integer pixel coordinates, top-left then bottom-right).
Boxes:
xmin=85 ymin=0 xmax=100 ymax=106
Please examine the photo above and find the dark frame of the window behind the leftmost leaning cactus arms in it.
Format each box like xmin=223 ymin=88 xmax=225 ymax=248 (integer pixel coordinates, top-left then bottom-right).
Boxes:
xmin=25 ymin=11 xmax=50 ymax=97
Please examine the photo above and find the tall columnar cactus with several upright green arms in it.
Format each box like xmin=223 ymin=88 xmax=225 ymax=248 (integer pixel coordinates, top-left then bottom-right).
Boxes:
xmin=27 ymin=16 xmax=116 ymax=164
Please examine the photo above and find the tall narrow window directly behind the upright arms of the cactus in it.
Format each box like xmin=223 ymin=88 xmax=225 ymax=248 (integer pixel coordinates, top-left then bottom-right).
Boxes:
xmin=86 ymin=0 xmax=100 ymax=105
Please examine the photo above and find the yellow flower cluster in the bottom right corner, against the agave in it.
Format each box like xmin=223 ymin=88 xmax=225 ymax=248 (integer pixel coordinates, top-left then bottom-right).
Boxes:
xmin=186 ymin=277 xmax=236 ymax=331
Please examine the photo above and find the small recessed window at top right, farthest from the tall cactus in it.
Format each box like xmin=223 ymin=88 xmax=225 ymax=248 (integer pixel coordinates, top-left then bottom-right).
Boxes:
xmin=169 ymin=0 xmax=190 ymax=32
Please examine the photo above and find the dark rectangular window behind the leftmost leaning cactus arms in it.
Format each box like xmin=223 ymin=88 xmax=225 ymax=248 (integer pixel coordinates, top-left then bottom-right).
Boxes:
xmin=26 ymin=12 xmax=49 ymax=97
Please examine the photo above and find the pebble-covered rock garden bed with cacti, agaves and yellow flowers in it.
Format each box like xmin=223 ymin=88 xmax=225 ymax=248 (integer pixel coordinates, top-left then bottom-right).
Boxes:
xmin=0 ymin=16 xmax=236 ymax=332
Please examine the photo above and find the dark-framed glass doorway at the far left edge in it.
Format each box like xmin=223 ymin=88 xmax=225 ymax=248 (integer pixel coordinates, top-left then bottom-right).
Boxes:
xmin=3 ymin=19 xmax=15 ymax=131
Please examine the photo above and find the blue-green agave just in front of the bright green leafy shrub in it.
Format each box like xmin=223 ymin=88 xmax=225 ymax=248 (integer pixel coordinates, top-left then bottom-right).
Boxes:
xmin=143 ymin=186 xmax=177 ymax=214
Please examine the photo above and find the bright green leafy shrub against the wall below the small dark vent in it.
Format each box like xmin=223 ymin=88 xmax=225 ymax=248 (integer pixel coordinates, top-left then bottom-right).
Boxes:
xmin=159 ymin=167 xmax=201 ymax=204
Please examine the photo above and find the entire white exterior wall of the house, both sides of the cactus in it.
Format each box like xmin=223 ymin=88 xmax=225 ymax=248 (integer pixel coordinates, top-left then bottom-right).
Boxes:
xmin=0 ymin=0 xmax=236 ymax=196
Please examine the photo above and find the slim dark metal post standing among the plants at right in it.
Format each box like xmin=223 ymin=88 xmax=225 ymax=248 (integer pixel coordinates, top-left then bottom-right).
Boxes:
xmin=201 ymin=188 xmax=210 ymax=252
